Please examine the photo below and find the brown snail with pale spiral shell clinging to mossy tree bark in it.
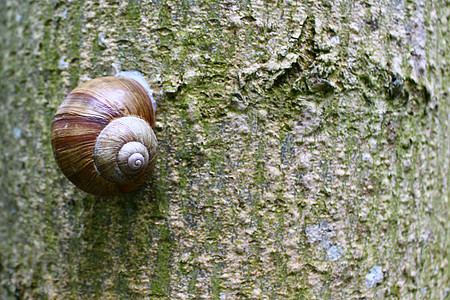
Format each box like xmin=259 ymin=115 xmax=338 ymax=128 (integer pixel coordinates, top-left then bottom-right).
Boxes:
xmin=51 ymin=71 xmax=158 ymax=196
